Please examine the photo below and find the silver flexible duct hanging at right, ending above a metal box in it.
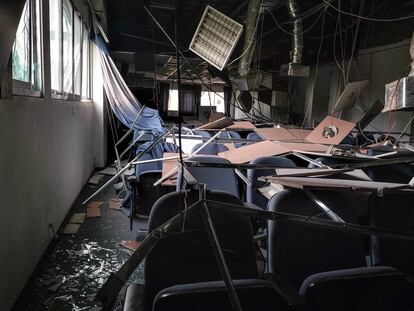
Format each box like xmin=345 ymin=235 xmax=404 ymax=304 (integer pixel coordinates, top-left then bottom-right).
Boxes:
xmin=288 ymin=0 xmax=303 ymax=64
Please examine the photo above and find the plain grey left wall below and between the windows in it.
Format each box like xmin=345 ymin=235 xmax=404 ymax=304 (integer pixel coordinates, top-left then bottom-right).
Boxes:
xmin=0 ymin=1 xmax=106 ymax=311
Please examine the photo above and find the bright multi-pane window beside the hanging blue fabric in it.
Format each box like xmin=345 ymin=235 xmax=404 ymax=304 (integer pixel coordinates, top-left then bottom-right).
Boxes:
xmin=49 ymin=0 xmax=90 ymax=99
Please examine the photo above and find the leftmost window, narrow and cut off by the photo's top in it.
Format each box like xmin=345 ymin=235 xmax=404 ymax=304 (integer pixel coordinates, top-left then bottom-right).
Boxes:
xmin=12 ymin=0 xmax=42 ymax=91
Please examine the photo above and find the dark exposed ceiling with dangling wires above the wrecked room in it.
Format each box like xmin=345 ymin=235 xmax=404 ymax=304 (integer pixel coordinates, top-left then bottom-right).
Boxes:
xmin=106 ymin=0 xmax=414 ymax=88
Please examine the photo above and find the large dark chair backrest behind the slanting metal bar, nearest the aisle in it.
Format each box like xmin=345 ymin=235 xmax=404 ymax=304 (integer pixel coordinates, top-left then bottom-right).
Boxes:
xmin=144 ymin=191 xmax=258 ymax=305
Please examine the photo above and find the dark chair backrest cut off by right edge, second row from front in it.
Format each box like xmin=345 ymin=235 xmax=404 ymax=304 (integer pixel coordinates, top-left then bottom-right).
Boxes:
xmin=369 ymin=192 xmax=414 ymax=277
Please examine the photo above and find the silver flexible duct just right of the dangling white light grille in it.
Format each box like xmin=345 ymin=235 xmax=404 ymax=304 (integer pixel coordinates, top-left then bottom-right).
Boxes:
xmin=239 ymin=0 xmax=261 ymax=78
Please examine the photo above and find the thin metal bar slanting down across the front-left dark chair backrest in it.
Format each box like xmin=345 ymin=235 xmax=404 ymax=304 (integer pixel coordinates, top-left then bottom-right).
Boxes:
xmin=200 ymin=197 xmax=242 ymax=311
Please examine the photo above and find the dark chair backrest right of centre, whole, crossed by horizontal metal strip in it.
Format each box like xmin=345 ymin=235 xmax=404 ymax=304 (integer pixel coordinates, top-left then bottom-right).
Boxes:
xmin=268 ymin=190 xmax=365 ymax=288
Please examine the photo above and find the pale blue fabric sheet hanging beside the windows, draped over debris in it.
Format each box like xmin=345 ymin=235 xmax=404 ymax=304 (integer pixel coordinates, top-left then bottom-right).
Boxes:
xmin=91 ymin=36 xmax=164 ymax=136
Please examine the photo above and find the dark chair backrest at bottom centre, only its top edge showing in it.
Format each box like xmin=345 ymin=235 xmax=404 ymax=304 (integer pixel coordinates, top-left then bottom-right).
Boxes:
xmin=153 ymin=280 xmax=290 ymax=311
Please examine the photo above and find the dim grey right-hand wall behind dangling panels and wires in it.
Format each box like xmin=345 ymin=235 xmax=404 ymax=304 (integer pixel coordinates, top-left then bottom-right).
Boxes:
xmin=304 ymin=39 xmax=412 ymax=135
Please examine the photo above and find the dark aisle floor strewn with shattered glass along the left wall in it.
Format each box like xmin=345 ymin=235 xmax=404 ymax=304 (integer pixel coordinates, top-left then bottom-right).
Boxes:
xmin=12 ymin=178 xmax=147 ymax=311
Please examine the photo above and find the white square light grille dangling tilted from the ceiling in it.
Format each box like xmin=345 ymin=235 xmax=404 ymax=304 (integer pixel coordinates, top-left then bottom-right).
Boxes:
xmin=190 ymin=5 xmax=243 ymax=70
